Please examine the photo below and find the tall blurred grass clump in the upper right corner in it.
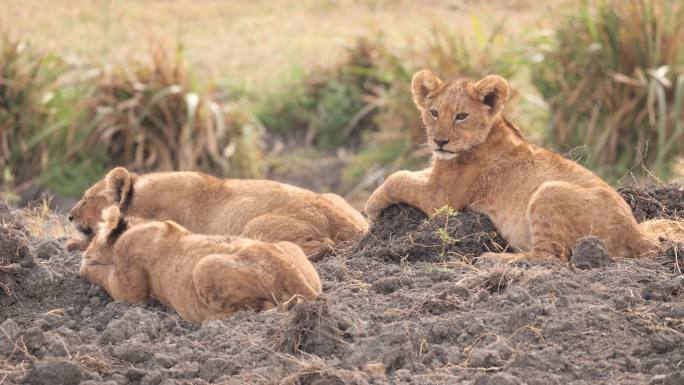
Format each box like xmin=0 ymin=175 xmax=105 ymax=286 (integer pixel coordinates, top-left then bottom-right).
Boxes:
xmin=532 ymin=0 xmax=684 ymax=178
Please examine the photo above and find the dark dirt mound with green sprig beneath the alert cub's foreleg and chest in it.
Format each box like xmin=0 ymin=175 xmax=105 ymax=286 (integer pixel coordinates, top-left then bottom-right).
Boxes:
xmin=346 ymin=204 xmax=508 ymax=262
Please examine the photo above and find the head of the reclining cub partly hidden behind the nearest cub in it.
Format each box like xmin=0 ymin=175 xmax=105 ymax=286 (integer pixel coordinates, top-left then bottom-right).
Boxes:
xmin=69 ymin=167 xmax=134 ymax=249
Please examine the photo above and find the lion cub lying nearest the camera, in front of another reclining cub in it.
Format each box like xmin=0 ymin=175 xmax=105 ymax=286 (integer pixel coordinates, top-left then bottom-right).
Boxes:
xmin=80 ymin=206 xmax=321 ymax=322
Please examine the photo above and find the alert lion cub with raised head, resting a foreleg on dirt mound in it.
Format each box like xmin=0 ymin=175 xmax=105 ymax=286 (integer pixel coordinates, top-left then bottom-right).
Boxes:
xmin=366 ymin=70 xmax=682 ymax=261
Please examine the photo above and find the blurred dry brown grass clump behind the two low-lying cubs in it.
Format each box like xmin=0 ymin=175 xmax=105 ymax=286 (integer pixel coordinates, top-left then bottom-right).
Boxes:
xmin=70 ymin=43 xmax=261 ymax=176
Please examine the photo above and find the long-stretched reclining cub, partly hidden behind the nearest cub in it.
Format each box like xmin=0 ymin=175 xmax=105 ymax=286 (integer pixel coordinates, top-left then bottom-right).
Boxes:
xmin=68 ymin=167 xmax=368 ymax=260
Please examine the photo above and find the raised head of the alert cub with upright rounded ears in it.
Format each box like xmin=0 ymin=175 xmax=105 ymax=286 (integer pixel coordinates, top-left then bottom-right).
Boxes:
xmin=411 ymin=70 xmax=509 ymax=160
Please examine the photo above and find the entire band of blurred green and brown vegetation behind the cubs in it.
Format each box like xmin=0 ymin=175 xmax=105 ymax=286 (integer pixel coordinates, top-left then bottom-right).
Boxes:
xmin=0 ymin=0 xmax=684 ymax=204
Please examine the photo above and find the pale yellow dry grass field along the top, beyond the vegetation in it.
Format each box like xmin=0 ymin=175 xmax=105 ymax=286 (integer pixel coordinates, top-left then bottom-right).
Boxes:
xmin=0 ymin=0 xmax=568 ymax=85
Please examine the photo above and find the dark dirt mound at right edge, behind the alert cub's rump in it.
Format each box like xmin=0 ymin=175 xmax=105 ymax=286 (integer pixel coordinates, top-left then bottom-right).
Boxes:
xmin=618 ymin=184 xmax=684 ymax=222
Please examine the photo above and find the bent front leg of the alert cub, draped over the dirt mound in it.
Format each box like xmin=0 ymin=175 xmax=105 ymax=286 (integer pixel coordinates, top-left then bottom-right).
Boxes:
xmin=365 ymin=170 xmax=439 ymax=221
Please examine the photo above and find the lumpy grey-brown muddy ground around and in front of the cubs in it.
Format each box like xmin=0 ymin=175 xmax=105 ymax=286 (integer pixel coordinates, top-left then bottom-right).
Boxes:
xmin=0 ymin=186 xmax=684 ymax=385
